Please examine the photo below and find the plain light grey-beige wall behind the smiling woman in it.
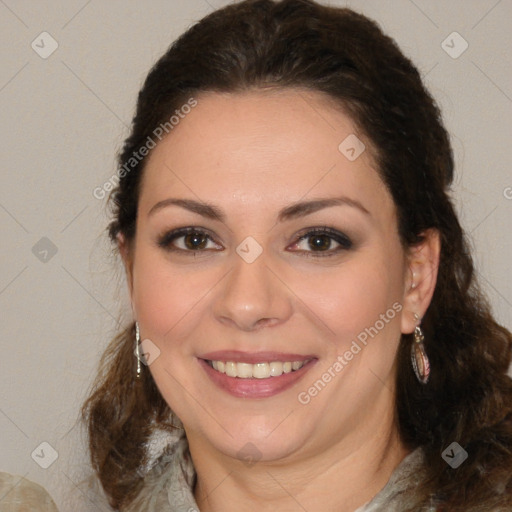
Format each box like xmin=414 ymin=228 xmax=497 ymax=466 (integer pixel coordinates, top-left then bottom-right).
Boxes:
xmin=0 ymin=0 xmax=512 ymax=511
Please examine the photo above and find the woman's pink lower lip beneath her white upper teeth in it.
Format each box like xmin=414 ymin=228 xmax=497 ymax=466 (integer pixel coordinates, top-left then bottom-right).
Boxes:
xmin=199 ymin=359 xmax=317 ymax=398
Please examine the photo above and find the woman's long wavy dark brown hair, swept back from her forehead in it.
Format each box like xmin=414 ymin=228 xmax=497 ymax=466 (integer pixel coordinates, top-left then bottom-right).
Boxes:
xmin=83 ymin=0 xmax=512 ymax=511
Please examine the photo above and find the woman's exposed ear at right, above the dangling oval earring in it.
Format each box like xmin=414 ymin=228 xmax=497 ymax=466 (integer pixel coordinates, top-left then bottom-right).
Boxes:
xmin=402 ymin=228 xmax=441 ymax=334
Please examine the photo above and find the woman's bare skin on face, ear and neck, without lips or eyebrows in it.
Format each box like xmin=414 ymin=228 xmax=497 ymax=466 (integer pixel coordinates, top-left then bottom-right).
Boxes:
xmin=119 ymin=89 xmax=439 ymax=512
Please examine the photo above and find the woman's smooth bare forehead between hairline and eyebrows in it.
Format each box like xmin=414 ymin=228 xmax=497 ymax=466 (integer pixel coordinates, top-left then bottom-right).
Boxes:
xmin=139 ymin=89 xmax=393 ymax=220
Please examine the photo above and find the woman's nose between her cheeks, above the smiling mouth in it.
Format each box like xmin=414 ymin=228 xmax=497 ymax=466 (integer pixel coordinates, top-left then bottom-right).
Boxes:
xmin=213 ymin=251 xmax=292 ymax=331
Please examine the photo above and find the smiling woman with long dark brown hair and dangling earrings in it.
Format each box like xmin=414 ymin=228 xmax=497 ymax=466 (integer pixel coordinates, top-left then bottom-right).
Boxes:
xmin=84 ymin=0 xmax=512 ymax=512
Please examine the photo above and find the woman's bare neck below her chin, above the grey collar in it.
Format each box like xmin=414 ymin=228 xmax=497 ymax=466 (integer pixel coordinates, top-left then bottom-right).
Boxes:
xmin=189 ymin=412 xmax=408 ymax=512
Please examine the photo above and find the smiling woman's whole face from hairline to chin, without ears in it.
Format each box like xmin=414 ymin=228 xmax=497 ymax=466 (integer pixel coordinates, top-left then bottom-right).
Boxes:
xmin=127 ymin=90 xmax=418 ymax=466
